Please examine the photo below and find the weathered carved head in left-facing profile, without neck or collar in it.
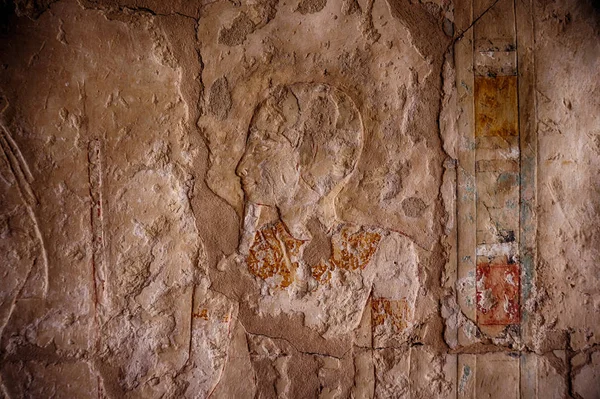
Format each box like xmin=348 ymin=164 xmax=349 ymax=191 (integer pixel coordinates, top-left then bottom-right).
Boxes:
xmin=236 ymin=83 xmax=362 ymax=206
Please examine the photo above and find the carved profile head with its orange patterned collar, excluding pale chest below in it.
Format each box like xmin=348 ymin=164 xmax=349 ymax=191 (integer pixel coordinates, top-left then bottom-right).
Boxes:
xmin=237 ymin=84 xmax=381 ymax=294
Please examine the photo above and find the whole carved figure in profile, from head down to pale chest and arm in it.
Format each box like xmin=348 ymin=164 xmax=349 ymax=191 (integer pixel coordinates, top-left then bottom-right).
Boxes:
xmin=236 ymin=83 xmax=418 ymax=342
